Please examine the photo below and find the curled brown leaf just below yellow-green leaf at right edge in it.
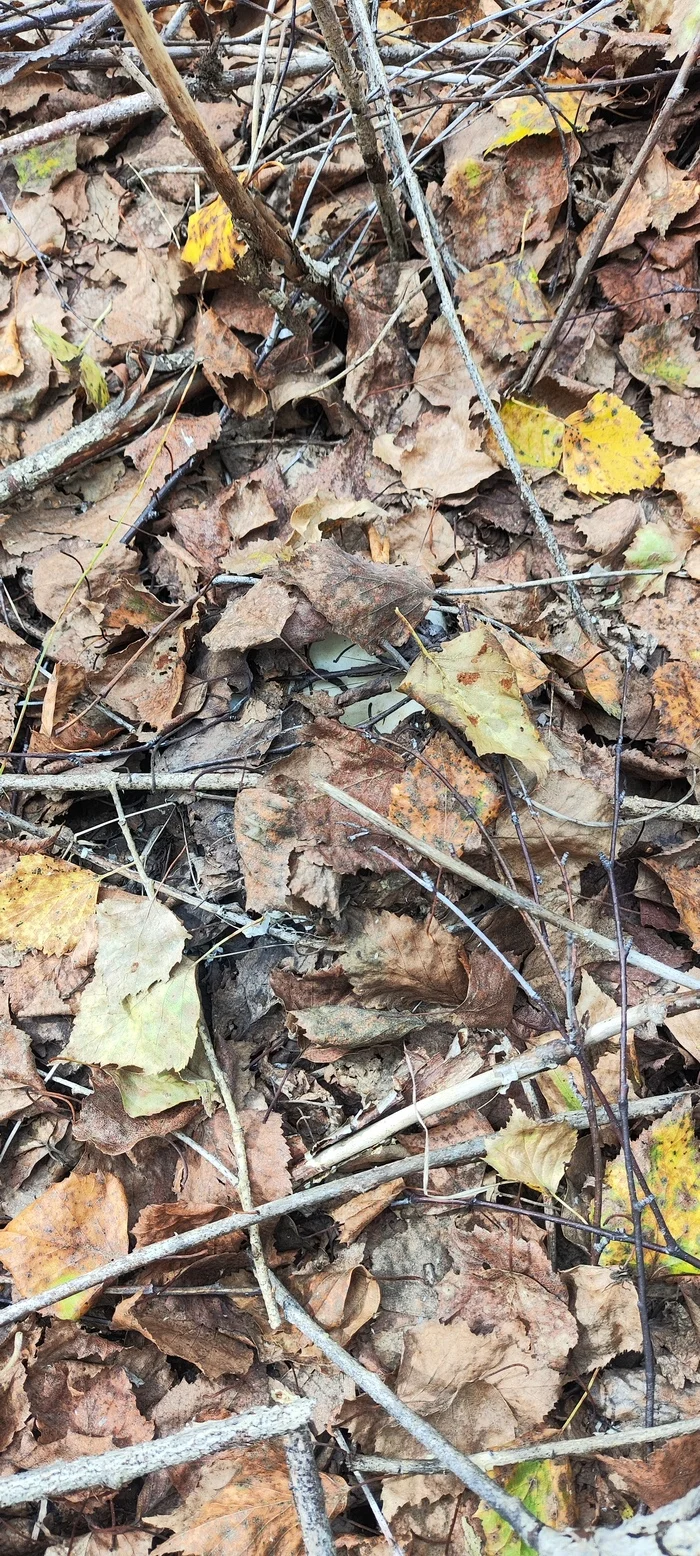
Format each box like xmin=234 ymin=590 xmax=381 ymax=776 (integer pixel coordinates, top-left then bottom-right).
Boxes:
xmin=562 ymin=1265 xmax=642 ymax=1377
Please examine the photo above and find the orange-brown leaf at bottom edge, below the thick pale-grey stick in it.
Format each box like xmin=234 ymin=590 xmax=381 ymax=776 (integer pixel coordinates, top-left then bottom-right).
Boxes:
xmin=148 ymin=1442 xmax=348 ymax=1556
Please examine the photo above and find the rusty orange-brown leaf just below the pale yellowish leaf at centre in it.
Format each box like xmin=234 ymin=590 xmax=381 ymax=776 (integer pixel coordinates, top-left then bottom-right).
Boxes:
xmin=389 ymin=731 xmax=501 ymax=856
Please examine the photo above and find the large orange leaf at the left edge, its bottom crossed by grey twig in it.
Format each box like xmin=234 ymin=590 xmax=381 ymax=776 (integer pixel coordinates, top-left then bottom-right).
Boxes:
xmin=0 ymin=1172 xmax=129 ymax=1318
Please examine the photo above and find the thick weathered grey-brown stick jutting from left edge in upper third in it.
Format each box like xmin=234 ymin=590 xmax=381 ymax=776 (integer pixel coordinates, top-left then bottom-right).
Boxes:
xmin=0 ymin=373 xmax=205 ymax=506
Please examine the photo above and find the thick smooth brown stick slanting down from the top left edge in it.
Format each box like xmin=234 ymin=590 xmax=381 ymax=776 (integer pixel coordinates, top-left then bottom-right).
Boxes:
xmin=109 ymin=0 xmax=336 ymax=293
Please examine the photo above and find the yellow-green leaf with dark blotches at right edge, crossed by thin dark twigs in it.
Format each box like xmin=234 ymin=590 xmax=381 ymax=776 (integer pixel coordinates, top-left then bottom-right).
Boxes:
xmin=600 ymin=1100 xmax=700 ymax=1276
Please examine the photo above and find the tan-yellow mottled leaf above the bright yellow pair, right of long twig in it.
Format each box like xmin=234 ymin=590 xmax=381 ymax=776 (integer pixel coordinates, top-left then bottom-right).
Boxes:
xmin=457 ymin=255 xmax=549 ymax=361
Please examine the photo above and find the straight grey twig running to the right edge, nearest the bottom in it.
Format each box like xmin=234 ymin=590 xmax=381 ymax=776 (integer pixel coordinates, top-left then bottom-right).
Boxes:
xmin=352 ymin=1416 xmax=700 ymax=1475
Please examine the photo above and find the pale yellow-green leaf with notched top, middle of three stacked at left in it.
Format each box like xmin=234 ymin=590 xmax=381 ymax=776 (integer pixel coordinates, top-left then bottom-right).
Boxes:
xmin=62 ymin=960 xmax=201 ymax=1075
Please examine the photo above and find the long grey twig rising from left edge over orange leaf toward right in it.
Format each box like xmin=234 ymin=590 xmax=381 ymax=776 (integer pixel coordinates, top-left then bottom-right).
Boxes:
xmin=0 ymin=1082 xmax=688 ymax=1327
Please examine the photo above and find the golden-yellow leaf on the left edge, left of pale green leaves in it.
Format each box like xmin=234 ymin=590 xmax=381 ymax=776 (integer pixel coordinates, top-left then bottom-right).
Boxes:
xmin=0 ymin=854 xmax=100 ymax=957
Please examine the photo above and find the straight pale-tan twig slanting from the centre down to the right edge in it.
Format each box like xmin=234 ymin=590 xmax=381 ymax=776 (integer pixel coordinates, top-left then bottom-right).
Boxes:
xmin=316 ymin=778 xmax=700 ymax=993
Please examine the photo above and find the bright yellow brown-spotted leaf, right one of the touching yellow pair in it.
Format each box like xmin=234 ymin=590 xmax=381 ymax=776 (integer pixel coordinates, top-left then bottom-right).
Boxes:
xmin=563 ymin=392 xmax=661 ymax=493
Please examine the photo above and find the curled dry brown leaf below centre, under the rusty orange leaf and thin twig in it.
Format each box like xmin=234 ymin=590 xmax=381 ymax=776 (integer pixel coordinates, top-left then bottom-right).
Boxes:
xmin=341 ymin=912 xmax=468 ymax=1008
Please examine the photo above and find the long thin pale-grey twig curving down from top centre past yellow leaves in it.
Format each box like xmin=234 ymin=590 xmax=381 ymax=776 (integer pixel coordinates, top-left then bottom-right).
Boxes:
xmin=347 ymin=0 xmax=597 ymax=643
